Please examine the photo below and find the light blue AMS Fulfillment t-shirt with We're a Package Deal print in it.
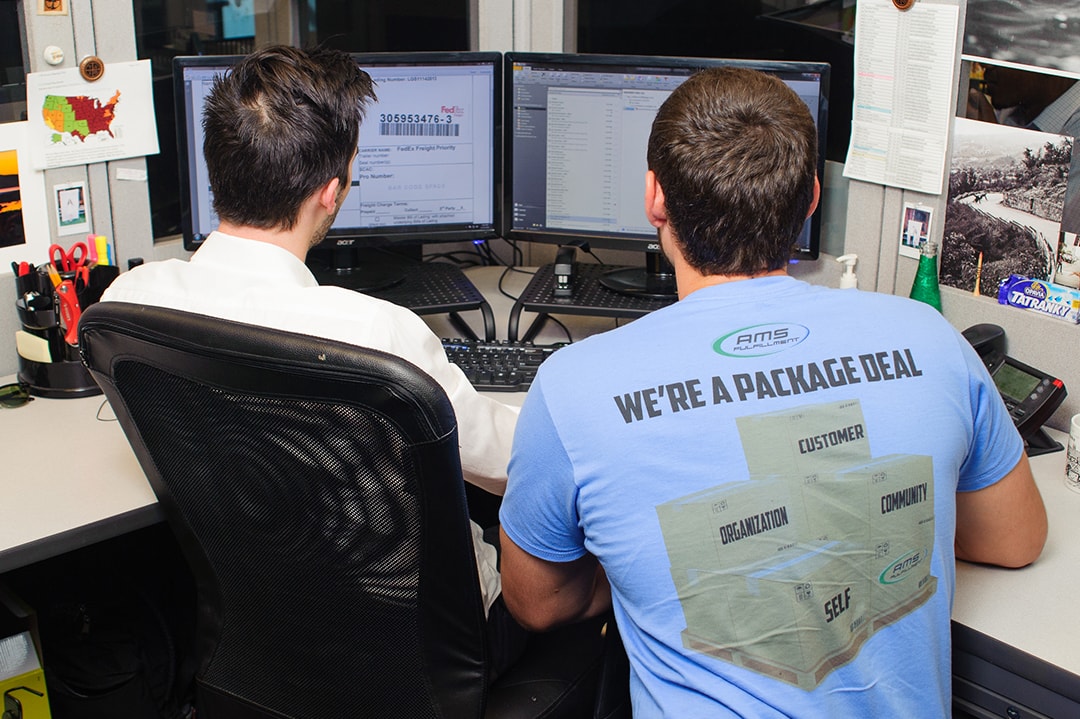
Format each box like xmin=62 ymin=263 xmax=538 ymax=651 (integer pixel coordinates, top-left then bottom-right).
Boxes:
xmin=500 ymin=276 xmax=1023 ymax=719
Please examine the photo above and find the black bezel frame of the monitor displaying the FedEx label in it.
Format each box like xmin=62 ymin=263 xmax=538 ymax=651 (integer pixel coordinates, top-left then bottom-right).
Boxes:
xmin=173 ymin=51 xmax=504 ymax=252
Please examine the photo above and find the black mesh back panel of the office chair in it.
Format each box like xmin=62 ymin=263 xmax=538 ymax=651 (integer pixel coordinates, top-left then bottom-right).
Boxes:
xmin=84 ymin=302 xmax=483 ymax=719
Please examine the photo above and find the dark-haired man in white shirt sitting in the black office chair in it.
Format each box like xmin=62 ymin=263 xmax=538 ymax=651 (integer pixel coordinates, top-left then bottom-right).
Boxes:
xmin=102 ymin=46 xmax=521 ymax=665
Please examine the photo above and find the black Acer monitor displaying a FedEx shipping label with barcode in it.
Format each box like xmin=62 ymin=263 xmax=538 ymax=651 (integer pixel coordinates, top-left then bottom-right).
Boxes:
xmin=173 ymin=52 xmax=502 ymax=289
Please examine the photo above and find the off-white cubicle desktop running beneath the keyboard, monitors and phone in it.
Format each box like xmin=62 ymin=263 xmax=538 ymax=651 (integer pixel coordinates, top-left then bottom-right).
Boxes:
xmin=0 ymin=260 xmax=1080 ymax=717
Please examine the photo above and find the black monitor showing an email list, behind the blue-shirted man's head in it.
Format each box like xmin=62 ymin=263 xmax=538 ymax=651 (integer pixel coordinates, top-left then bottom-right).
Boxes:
xmin=503 ymin=52 xmax=829 ymax=298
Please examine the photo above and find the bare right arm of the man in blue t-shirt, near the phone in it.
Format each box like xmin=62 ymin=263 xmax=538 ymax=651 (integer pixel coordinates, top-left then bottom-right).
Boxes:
xmin=956 ymin=455 xmax=1047 ymax=567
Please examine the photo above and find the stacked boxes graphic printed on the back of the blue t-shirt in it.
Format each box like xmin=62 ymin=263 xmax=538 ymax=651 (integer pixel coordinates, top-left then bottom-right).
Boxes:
xmin=657 ymin=401 xmax=936 ymax=690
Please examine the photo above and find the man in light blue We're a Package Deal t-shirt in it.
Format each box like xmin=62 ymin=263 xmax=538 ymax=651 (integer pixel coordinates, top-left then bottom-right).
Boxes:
xmin=500 ymin=68 xmax=1047 ymax=719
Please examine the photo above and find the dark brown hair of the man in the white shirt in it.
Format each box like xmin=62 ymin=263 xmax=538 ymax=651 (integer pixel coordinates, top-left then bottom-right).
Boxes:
xmin=203 ymin=45 xmax=375 ymax=229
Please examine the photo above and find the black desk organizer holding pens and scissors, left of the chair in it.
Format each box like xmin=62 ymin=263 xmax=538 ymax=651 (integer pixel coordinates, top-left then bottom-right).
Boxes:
xmin=15 ymin=266 xmax=120 ymax=398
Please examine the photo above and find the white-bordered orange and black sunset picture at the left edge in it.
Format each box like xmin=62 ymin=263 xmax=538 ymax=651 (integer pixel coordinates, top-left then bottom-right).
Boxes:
xmin=0 ymin=122 xmax=50 ymax=268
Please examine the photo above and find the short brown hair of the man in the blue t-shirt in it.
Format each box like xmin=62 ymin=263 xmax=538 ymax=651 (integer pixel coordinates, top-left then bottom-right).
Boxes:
xmin=648 ymin=66 xmax=818 ymax=274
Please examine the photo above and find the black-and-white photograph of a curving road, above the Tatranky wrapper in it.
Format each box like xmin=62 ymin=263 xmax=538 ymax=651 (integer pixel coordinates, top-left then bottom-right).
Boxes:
xmin=940 ymin=118 xmax=1072 ymax=297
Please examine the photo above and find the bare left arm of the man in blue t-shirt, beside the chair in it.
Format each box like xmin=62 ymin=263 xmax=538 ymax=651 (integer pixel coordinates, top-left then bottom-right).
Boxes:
xmin=499 ymin=528 xmax=611 ymax=632
